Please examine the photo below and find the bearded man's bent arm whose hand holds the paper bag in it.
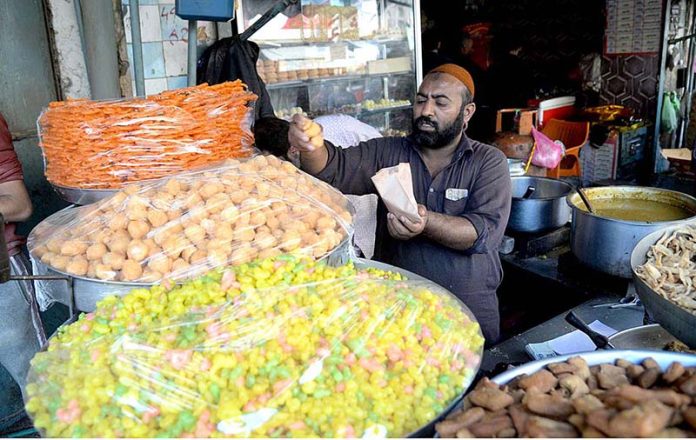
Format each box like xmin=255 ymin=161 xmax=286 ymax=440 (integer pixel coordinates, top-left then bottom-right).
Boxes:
xmin=387 ymin=154 xmax=511 ymax=254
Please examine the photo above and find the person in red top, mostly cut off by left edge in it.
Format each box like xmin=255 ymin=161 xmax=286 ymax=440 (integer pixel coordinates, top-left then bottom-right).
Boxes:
xmin=0 ymin=114 xmax=46 ymax=432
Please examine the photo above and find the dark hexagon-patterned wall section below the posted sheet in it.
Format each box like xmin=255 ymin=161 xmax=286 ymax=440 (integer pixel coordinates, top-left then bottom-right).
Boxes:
xmin=600 ymin=55 xmax=660 ymax=120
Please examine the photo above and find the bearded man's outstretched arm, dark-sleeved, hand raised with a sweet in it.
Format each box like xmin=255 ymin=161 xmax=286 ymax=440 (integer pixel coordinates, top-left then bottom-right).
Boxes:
xmin=288 ymin=115 xmax=388 ymax=195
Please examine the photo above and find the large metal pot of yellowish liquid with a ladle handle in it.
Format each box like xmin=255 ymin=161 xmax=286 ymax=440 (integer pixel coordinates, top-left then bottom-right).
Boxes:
xmin=567 ymin=186 xmax=696 ymax=278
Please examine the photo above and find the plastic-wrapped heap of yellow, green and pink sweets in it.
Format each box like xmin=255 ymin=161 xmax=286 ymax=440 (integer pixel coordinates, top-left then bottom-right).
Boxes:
xmin=26 ymin=255 xmax=484 ymax=438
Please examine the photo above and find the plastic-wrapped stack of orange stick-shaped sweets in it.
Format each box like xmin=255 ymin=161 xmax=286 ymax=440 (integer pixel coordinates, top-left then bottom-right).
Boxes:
xmin=38 ymin=81 xmax=256 ymax=189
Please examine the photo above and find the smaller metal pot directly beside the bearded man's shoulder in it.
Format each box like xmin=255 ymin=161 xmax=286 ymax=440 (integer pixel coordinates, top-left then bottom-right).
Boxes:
xmin=507 ymin=176 xmax=573 ymax=232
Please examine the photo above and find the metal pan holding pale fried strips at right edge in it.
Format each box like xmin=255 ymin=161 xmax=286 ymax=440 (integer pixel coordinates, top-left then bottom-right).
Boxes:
xmin=631 ymin=224 xmax=696 ymax=348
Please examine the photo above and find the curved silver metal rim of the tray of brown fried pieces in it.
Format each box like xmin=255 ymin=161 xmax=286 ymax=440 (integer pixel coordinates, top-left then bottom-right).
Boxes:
xmin=491 ymin=350 xmax=696 ymax=385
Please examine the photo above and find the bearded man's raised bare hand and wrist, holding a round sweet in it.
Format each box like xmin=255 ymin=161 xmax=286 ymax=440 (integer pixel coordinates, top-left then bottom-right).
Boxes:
xmin=288 ymin=115 xmax=329 ymax=174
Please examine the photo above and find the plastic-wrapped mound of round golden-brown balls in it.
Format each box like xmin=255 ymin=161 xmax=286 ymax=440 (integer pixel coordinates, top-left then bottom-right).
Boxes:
xmin=28 ymin=156 xmax=352 ymax=283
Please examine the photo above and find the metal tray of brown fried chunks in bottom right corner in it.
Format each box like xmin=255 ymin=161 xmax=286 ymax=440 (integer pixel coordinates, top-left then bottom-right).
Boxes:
xmin=436 ymin=350 xmax=696 ymax=438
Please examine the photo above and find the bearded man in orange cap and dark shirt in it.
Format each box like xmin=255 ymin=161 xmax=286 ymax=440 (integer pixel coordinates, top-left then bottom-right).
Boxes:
xmin=288 ymin=64 xmax=511 ymax=344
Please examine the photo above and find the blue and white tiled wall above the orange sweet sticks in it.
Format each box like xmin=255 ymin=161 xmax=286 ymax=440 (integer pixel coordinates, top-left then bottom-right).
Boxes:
xmin=121 ymin=0 xmax=217 ymax=95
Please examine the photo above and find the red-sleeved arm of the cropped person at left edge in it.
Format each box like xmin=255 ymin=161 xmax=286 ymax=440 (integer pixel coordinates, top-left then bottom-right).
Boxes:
xmin=0 ymin=114 xmax=32 ymax=222
